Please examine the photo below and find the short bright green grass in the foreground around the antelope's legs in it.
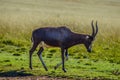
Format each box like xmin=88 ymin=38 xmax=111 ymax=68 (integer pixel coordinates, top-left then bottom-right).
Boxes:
xmin=0 ymin=46 xmax=120 ymax=79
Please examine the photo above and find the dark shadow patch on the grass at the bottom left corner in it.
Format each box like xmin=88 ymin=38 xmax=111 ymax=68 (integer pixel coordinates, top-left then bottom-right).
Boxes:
xmin=0 ymin=70 xmax=33 ymax=77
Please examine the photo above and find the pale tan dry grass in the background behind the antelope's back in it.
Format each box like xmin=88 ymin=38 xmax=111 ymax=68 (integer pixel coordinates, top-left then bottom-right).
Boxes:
xmin=0 ymin=0 xmax=120 ymax=41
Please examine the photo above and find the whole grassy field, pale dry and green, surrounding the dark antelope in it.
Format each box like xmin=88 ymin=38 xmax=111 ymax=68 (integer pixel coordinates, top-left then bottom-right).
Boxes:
xmin=0 ymin=0 xmax=120 ymax=80
